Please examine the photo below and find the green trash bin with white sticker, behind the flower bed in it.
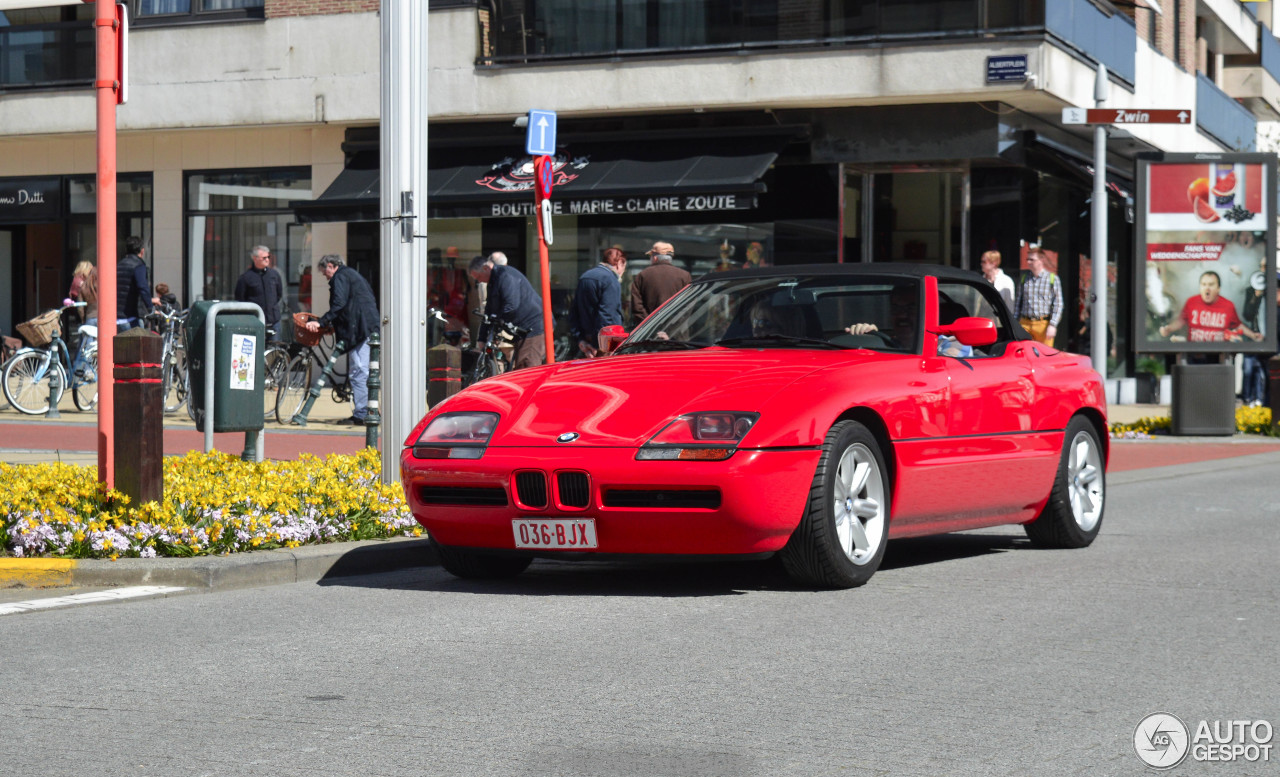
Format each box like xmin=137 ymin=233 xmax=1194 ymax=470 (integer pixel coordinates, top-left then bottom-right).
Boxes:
xmin=186 ymin=300 xmax=266 ymax=433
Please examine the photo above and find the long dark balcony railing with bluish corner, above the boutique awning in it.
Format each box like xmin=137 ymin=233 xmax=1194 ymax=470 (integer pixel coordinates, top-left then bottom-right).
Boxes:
xmin=480 ymin=0 xmax=1138 ymax=83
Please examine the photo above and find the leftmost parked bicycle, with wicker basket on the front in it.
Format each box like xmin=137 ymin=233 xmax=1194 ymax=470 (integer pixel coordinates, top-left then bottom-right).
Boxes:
xmin=0 ymin=302 xmax=97 ymax=416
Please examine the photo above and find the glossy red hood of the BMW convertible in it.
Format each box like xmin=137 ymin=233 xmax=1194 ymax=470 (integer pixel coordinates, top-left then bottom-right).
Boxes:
xmin=453 ymin=348 xmax=869 ymax=447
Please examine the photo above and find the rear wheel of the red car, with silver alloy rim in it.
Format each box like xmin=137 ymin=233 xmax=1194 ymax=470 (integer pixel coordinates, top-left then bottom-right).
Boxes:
xmin=1024 ymin=416 xmax=1107 ymax=548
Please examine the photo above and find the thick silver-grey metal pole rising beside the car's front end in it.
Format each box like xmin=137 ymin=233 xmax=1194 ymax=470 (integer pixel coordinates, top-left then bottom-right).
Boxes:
xmin=379 ymin=0 xmax=428 ymax=484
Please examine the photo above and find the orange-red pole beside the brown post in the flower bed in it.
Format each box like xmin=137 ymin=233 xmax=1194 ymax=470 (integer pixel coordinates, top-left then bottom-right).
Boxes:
xmin=93 ymin=0 xmax=118 ymax=488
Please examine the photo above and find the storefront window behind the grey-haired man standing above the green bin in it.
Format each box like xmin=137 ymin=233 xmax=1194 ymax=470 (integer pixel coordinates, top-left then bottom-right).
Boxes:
xmin=186 ymin=168 xmax=314 ymax=307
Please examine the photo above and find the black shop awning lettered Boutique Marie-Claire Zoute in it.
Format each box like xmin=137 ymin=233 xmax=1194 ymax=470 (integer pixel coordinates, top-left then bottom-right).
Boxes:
xmin=291 ymin=136 xmax=787 ymax=221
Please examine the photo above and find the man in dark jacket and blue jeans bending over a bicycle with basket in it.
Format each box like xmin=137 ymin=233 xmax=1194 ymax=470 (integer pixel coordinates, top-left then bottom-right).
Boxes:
xmin=307 ymin=253 xmax=378 ymax=426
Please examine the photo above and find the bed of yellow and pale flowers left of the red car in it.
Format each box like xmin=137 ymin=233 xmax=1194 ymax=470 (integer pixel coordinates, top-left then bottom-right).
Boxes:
xmin=0 ymin=448 xmax=422 ymax=559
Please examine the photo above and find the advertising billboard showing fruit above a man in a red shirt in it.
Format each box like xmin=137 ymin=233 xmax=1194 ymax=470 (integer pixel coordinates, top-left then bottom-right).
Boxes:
xmin=1133 ymin=154 xmax=1276 ymax=353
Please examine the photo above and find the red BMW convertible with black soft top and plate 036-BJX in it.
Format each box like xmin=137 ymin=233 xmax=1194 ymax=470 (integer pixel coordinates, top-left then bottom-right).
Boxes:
xmin=401 ymin=264 xmax=1107 ymax=588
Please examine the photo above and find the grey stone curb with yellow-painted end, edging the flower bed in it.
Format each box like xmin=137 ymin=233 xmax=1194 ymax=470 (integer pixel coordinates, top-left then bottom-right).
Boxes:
xmin=0 ymin=538 xmax=438 ymax=590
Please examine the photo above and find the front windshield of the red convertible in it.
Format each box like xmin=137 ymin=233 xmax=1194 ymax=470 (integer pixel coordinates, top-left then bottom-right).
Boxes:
xmin=621 ymin=275 xmax=920 ymax=353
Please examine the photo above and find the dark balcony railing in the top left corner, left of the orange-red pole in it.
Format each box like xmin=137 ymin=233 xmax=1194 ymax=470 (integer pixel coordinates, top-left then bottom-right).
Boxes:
xmin=0 ymin=22 xmax=95 ymax=91
